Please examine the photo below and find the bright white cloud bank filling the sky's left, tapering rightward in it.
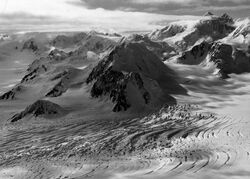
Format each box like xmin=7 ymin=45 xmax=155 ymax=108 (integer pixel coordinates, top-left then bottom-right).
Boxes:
xmin=0 ymin=0 xmax=203 ymax=32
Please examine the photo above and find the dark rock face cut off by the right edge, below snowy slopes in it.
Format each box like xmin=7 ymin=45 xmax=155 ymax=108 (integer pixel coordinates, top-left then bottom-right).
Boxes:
xmin=208 ymin=43 xmax=250 ymax=78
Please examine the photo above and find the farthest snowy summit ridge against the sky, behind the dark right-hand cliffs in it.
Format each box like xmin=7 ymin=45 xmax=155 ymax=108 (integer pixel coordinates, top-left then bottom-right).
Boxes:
xmin=149 ymin=14 xmax=235 ymax=51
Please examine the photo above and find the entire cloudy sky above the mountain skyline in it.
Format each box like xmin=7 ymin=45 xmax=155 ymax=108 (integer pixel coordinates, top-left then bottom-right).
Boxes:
xmin=0 ymin=0 xmax=250 ymax=32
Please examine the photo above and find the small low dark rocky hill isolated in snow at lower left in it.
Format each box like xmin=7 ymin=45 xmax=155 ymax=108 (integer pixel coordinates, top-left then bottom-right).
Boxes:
xmin=10 ymin=100 xmax=65 ymax=122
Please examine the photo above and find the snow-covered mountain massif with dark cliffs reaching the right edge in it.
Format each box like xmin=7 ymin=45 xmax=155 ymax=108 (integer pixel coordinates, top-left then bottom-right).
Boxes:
xmin=162 ymin=13 xmax=250 ymax=78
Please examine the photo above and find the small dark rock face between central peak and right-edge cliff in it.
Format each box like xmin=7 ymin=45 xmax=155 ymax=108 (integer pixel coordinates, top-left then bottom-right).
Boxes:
xmin=177 ymin=41 xmax=212 ymax=65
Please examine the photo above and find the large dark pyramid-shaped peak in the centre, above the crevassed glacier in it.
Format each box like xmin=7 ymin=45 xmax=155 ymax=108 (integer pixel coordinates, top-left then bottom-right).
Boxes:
xmin=87 ymin=40 xmax=185 ymax=112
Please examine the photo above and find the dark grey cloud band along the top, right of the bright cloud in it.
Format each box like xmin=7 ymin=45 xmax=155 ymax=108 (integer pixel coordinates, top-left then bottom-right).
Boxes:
xmin=82 ymin=0 xmax=250 ymax=17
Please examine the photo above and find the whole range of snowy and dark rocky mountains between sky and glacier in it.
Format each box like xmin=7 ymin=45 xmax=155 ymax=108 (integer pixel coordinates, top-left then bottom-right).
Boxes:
xmin=0 ymin=12 xmax=250 ymax=122
